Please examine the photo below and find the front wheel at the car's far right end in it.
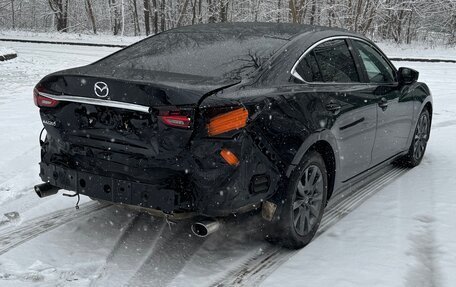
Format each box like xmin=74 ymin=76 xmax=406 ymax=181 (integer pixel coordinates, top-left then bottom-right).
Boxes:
xmin=399 ymin=109 xmax=431 ymax=167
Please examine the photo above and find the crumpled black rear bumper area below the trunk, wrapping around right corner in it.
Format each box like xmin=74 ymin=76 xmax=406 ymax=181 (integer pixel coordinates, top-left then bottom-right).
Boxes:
xmin=40 ymin=134 xmax=279 ymax=217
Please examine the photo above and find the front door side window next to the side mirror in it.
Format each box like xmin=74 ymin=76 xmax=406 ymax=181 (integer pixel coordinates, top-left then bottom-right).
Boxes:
xmin=353 ymin=40 xmax=395 ymax=83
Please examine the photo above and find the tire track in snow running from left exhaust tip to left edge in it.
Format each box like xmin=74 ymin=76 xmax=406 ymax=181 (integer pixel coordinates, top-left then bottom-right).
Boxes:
xmin=0 ymin=202 xmax=110 ymax=255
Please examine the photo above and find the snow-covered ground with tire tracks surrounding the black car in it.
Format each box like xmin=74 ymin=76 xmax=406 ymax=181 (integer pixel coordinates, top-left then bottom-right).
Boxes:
xmin=0 ymin=42 xmax=456 ymax=286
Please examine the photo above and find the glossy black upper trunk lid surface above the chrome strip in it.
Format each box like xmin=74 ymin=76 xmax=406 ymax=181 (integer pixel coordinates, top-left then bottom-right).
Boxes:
xmin=41 ymin=65 xmax=240 ymax=107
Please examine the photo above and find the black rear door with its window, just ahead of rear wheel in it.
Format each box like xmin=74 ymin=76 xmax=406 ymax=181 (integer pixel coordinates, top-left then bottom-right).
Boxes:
xmin=295 ymin=38 xmax=378 ymax=181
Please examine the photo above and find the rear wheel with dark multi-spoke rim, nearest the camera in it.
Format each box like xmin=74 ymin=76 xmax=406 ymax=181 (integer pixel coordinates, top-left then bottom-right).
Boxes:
xmin=273 ymin=150 xmax=328 ymax=249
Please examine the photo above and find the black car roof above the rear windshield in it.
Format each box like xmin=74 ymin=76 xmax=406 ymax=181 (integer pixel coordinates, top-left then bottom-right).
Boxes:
xmin=160 ymin=22 xmax=348 ymax=40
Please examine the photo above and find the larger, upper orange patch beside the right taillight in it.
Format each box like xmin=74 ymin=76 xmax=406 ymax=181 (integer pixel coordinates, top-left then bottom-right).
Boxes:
xmin=207 ymin=108 xmax=249 ymax=136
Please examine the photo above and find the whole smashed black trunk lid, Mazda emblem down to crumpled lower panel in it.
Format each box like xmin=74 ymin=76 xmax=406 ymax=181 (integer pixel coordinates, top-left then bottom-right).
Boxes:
xmin=38 ymin=66 xmax=237 ymax=163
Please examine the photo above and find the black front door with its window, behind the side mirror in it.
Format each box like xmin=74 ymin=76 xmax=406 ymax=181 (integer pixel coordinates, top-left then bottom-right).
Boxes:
xmin=351 ymin=39 xmax=413 ymax=165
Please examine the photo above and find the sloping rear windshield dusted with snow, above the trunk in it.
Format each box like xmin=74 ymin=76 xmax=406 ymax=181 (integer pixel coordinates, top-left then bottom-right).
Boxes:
xmin=100 ymin=32 xmax=287 ymax=78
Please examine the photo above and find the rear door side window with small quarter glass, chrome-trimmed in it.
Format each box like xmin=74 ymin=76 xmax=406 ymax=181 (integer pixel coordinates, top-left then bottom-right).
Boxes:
xmin=296 ymin=39 xmax=360 ymax=83
